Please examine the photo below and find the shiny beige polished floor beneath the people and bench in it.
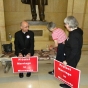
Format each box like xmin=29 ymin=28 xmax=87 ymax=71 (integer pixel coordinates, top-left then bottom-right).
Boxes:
xmin=0 ymin=51 xmax=88 ymax=88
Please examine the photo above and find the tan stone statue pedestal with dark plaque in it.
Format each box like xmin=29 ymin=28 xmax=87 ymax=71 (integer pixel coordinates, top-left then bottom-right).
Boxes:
xmin=28 ymin=21 xmax=53 ymax=50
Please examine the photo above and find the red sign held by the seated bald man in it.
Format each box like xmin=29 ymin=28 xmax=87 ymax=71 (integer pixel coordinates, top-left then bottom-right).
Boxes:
xmin=11 ymin=56 xmax=38 ymax=73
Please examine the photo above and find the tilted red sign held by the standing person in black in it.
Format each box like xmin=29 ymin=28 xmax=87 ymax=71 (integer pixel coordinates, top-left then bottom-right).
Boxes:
xmin=54 ymin=60 xmax=80 ymax=88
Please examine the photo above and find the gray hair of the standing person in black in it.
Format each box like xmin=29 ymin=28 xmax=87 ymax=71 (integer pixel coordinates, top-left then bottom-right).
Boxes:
xmin=64 ymin=16 xmax=79 ymax=28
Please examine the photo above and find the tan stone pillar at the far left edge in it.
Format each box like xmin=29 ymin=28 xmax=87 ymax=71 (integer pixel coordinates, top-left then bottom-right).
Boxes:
xmin=0 ymin=0 xmax=6 ymax=53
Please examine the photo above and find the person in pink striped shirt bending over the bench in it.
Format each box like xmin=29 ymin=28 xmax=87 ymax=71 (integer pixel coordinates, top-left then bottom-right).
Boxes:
xmin=47 ymin=22 xmax=67 ymax=75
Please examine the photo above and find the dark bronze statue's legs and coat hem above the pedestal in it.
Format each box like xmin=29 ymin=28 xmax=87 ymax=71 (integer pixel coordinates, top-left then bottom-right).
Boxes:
xmin=21 ymin=0 xmax=48 ymax=21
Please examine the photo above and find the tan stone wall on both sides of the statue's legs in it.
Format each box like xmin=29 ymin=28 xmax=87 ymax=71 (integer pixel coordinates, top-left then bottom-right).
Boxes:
xmin=3 ymin=0 xmax=68 ymax=39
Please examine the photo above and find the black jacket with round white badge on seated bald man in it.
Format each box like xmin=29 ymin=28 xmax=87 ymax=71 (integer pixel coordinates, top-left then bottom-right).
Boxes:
xmin=14 ymin=30 xmax=34 ymax=56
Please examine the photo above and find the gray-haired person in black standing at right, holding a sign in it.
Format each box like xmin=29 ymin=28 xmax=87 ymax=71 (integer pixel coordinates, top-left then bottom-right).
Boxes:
xmin=60 ymin=16 xmax=83 ymax=88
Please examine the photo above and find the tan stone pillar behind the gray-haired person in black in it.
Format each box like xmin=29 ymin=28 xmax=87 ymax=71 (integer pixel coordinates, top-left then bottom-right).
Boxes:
xmin=67 ymin=0 xmax=86 ymax=29
